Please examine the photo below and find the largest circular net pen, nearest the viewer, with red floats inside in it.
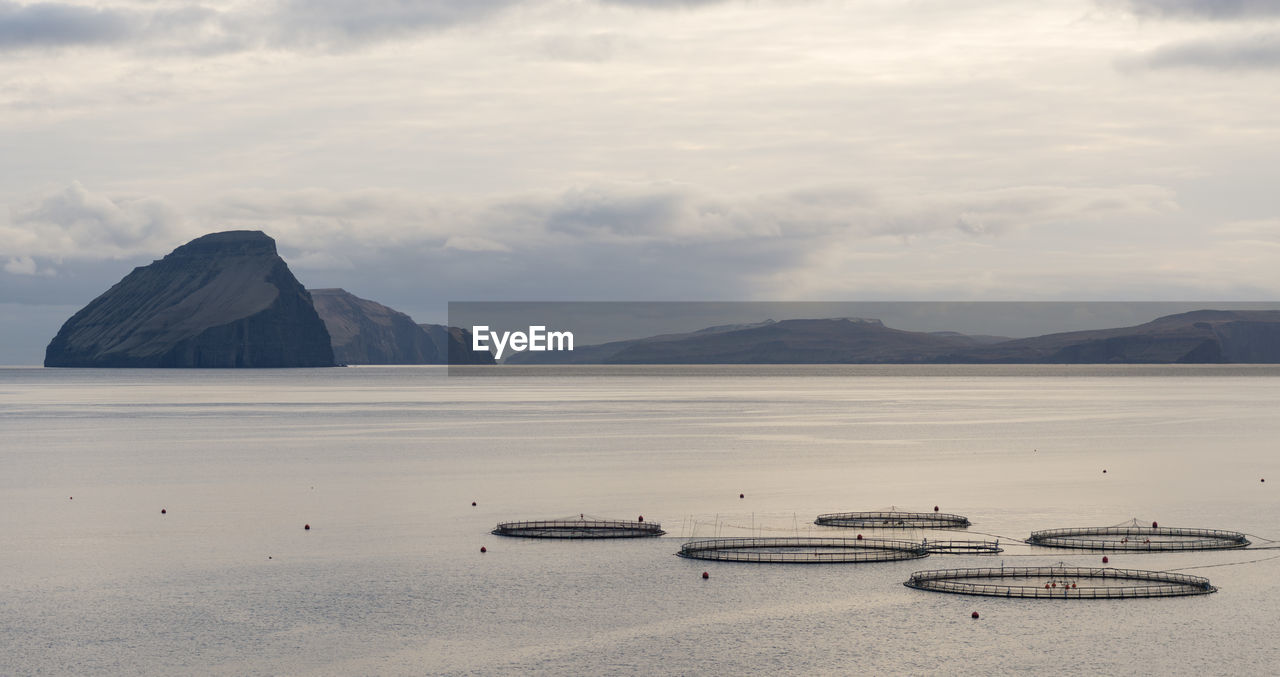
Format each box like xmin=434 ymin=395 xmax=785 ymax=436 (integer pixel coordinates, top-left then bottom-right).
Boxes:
xmin=902 ymin=566 xmax=1217 ymax=599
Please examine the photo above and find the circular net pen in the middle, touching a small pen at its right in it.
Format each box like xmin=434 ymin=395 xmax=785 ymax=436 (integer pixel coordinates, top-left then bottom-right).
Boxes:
xmin=676 ymin=536 xmax=929 ymax=564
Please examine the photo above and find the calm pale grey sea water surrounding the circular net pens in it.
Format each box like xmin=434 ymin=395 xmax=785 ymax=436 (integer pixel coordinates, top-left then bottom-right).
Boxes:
xmin=0 ymin=367 xmax=1280 ymax=674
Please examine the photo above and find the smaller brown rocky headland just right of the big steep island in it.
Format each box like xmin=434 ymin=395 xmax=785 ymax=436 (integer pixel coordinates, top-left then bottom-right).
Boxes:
xmin=310 ymin=289 xmax=444 ymax=365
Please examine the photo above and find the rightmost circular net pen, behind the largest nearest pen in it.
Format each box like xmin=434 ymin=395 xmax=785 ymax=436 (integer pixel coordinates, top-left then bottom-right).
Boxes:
xmin=1027 ymin=526 xmax=1249 ymax=552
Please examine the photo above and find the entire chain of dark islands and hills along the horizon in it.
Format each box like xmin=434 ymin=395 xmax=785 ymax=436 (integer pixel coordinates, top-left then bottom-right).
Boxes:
xmin=45 ymin=230 xmax=1280 ymax=367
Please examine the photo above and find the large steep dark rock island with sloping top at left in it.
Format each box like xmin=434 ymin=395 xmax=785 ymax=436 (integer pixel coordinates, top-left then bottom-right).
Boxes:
xmin=45 ymin=230 xmax=334 ymax=367
